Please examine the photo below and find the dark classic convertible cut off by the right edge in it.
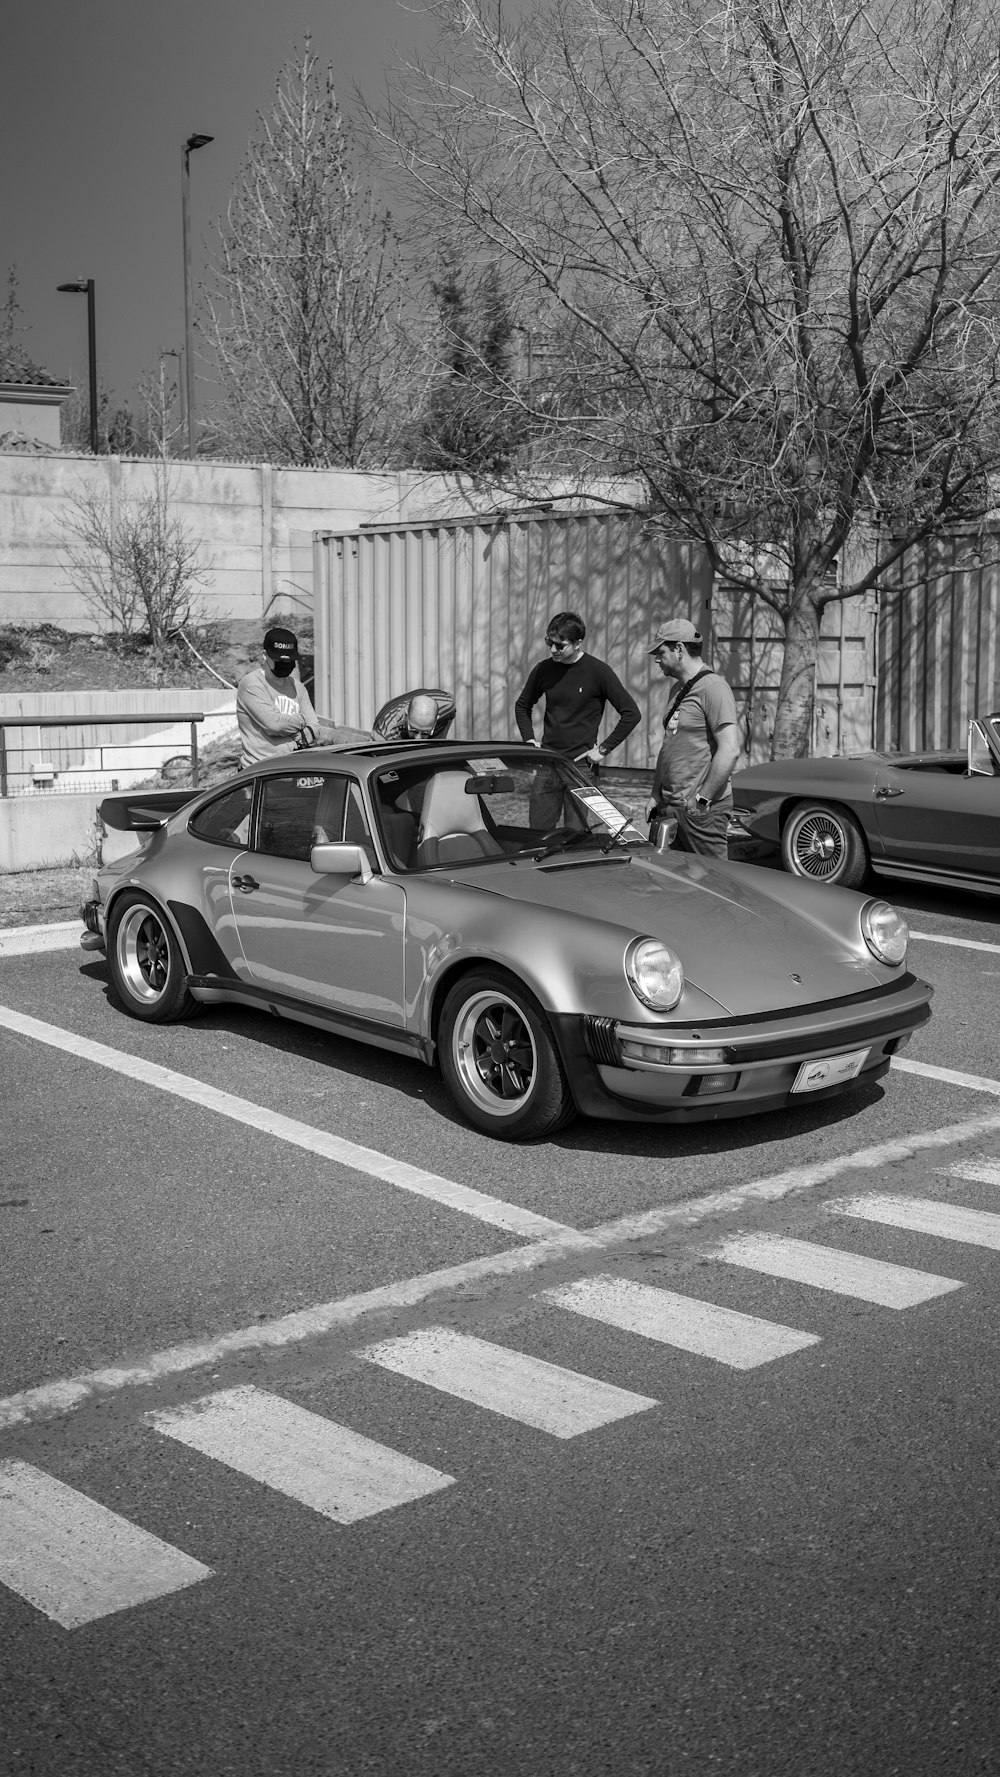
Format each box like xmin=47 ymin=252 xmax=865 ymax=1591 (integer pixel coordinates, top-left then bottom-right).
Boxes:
xmin=732 ymin=714 xmax=1000 ymax=894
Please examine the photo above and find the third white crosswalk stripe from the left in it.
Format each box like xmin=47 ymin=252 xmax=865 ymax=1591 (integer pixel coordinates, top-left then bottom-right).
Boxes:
xmin=359 ymin=1327 xmax=659 ymax=1438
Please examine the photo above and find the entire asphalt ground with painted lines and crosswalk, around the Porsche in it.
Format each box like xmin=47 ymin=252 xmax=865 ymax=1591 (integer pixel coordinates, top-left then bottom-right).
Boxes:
xmin=0 ymin=877 xmax=1000 ymax=1777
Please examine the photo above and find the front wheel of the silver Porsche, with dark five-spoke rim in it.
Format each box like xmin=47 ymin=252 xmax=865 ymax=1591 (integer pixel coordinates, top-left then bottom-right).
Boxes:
xmin=437 ymin=968 xmax=575 ymax=1141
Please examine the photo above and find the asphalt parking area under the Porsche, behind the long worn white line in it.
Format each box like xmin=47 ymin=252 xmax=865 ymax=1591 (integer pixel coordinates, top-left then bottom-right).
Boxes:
xmin=0 ymin=877 xmax=1000 ymax=1393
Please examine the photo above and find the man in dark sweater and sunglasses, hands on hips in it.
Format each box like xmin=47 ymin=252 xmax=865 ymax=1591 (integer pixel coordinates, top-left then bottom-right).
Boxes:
xmin=513 ymin=611 xmax=641 ymax=773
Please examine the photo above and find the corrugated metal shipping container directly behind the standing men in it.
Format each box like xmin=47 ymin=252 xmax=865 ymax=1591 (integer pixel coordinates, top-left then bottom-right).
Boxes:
xmin=313 ymin=514 xmax=874 ymax=768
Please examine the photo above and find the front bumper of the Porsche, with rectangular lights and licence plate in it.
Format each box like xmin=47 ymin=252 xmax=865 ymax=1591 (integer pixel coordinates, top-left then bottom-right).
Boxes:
xmin=552 ymin=974 xmax=933 ymax=1123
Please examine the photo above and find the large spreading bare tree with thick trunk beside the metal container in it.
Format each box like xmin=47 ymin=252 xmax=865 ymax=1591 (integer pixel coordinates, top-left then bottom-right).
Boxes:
xmin=375 ymin=0 xmax=1000 ymax=753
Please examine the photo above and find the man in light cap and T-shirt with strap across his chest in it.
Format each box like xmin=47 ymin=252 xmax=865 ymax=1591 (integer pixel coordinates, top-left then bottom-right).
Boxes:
xmin=647 ymin=617 xmax=739 ymax=858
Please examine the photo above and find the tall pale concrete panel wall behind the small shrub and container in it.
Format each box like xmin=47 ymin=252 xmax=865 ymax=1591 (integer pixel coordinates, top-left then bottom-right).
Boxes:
xmin=0 ymin=453 xmax=632 ymax=633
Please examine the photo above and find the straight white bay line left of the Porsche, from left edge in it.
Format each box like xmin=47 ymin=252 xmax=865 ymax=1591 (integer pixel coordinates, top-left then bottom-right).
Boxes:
xmin=0 ymin=1006 xmax=572 ymax=1240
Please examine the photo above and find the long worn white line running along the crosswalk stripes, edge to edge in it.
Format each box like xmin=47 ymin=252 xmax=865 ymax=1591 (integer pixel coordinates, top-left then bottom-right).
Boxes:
xmin=0 ymin=1116 xmax=1000 ymax=1430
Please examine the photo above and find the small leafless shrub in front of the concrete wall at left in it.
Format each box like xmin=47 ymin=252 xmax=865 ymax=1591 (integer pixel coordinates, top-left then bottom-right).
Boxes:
xmin=64 ymin=460 xmax=211 ymax=665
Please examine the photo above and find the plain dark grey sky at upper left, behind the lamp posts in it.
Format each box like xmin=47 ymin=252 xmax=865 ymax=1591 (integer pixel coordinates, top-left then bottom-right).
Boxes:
xmin=0 ymin=0 xmax=430 ymax=417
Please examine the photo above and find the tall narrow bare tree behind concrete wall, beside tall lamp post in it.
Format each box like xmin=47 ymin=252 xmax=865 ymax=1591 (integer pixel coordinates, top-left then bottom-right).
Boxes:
xmin=208 ymin=43 xmax=409 ymax=467
